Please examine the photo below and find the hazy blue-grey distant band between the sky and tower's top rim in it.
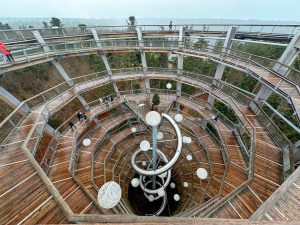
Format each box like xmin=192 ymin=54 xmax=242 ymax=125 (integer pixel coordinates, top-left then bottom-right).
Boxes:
xmin=0 ymin=18 xmax=300 ymax=29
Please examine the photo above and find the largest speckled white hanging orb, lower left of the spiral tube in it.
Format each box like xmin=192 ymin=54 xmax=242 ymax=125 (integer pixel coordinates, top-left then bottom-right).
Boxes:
xmin=97 ymin=181 xmax=122 ymax=209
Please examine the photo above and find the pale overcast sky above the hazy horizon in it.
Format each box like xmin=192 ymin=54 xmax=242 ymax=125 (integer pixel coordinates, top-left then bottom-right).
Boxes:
xmin=0 ymin=0 xmax=300 ymax=21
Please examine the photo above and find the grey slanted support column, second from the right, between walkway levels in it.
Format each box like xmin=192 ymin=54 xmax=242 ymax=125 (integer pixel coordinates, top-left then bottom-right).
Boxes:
xmin=206 ymin=27 xmax=237 ymax=110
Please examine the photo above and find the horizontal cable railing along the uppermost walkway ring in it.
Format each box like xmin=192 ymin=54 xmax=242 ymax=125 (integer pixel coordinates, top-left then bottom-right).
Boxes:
xmin=0 ymin=24 xmax=300 ymax=42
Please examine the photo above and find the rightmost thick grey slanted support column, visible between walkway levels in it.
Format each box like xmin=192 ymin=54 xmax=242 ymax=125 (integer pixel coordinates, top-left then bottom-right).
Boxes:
xmin=250 ymin=30 xmax=300 ymax=112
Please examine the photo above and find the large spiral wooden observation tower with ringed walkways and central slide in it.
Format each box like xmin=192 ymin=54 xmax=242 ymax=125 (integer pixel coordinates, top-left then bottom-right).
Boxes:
xmin=0 ymin=24 xmax=300 ymax=224
